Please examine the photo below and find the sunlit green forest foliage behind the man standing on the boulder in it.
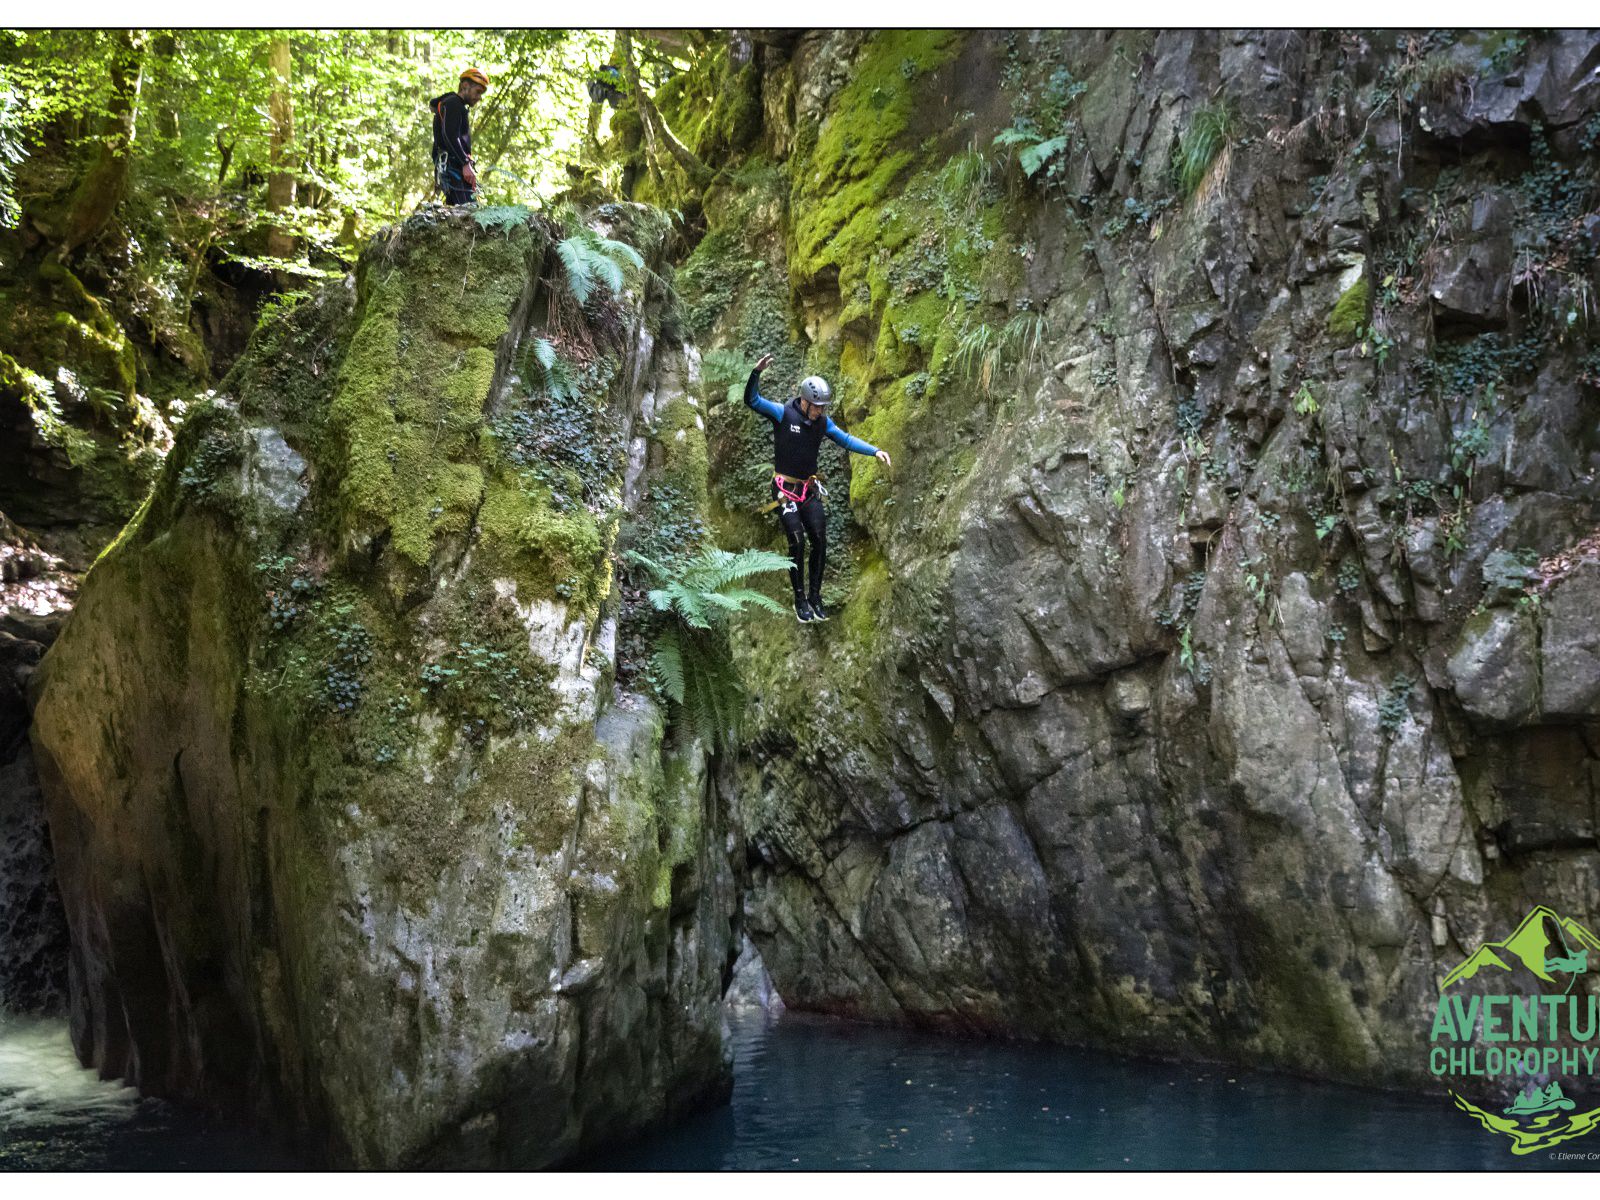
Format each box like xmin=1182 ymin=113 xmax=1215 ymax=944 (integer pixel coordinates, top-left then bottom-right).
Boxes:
xmin=0 ymin=29 xmax=700 ymax=275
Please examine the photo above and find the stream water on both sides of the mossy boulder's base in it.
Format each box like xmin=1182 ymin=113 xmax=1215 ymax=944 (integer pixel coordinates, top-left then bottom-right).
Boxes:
xmin=0 ymin=1013 xmax=1574 ymax=1171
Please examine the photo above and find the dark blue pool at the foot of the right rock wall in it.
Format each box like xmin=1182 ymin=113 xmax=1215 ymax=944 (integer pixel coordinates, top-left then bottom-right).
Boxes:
xmin=586 ymin=1013 xmax=1561 ymax=1170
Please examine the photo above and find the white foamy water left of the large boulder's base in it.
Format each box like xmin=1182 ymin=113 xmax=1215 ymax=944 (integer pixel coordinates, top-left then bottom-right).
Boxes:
xmin=0 ymin=1013 xmax=139 ymax=1141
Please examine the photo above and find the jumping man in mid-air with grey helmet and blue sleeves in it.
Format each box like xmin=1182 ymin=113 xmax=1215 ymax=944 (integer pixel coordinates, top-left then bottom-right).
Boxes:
xmin=744 ymin=354 xmax=890 ymax=621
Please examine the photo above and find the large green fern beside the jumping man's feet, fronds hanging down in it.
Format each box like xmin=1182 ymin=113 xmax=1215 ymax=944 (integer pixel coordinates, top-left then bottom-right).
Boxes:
xmin=626 ymin=546 xmax=789 ymax=747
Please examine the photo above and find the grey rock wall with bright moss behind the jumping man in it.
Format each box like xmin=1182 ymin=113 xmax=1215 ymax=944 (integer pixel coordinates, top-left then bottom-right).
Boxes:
xmin=659 ymin=32 xmax=1600 ymax=1083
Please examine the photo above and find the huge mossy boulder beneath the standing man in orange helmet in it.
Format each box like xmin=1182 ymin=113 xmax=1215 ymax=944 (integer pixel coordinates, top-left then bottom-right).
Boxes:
xmin=34 ymin=206 xmax=738 ymax=1166
